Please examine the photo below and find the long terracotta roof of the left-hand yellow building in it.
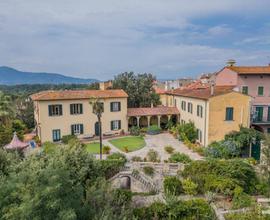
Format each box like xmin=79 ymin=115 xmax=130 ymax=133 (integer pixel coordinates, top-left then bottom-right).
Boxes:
xmin=31 ymin=89 xmax=128 ymax=101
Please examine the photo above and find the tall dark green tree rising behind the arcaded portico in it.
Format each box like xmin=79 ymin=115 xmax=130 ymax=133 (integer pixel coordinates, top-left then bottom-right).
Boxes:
xmin=113 ymin=72 xmax=160 ymax=108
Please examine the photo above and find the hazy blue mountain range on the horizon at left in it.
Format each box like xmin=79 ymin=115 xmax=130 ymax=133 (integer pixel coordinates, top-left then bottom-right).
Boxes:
xmin=0 ymin=66 xmax=99 ymax=85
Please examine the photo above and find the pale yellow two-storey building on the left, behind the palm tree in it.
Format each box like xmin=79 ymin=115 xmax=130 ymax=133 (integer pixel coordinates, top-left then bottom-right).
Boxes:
xmin=31 ymin=90 xmax=128 ymax=142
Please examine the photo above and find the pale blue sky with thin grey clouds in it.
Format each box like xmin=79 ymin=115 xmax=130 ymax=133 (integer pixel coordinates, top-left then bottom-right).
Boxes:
xmin=0 ymin=0 xmax=270 ymax=80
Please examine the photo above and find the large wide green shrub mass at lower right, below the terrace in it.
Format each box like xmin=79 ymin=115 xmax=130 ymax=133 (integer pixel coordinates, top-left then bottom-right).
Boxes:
xmin=181 ymin=159 xmax=258 ymax=193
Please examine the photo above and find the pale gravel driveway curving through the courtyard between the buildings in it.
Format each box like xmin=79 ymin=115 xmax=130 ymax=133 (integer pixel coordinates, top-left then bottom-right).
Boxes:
xmin=103 ymin=133 xmax=203 ymax=161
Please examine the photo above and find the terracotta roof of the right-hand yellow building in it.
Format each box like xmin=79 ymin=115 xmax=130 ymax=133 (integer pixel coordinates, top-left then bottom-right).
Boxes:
xmin=168 ymin=86 xmax=237 ymax=100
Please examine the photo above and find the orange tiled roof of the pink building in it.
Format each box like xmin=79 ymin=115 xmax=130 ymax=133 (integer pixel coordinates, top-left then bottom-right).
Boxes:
xmin=225 ymin=66 xmax=270 ymax=74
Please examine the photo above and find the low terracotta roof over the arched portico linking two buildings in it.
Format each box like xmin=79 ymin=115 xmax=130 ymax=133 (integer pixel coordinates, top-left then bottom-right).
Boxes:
xmin=127 ymin=106 xmax=180 ymax=116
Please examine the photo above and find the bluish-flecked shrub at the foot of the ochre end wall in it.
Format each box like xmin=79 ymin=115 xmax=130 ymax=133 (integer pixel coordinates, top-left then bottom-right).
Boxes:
xmin=205 ymin=140 xmax=241 ymax=159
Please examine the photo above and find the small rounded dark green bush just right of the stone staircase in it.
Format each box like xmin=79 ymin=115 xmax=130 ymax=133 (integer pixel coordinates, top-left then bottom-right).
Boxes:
xmin=163 ymin=176 xmax=183 ymax=196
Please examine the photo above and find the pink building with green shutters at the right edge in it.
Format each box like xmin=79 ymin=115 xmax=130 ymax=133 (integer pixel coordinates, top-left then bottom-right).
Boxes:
xmin=215 ymin=65 xmax=270 ymax=133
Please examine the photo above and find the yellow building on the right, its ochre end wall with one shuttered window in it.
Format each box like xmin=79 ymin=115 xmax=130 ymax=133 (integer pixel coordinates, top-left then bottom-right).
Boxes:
xmin=162 ymin=86 xmax=251 ymax=146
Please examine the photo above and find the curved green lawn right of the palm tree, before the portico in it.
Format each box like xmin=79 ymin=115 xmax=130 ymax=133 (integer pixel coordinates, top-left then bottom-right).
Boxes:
xmin=109 ymin=136 xmax=145 ymax=152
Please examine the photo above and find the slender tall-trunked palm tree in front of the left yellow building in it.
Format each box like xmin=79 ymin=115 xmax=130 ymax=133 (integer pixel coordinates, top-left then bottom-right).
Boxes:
xmin=89 ymin=98 xmax=104 ymax=159
